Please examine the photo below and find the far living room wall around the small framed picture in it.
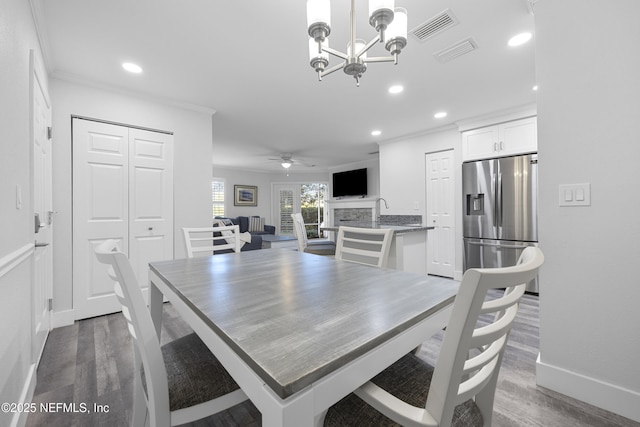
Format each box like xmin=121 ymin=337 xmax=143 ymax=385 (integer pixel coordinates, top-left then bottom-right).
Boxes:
xmin=213 ymin=166 xmax=329 ymax=225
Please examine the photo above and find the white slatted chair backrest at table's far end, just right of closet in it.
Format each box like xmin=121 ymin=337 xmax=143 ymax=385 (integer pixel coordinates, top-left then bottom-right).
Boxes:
xmin=182 ymin=225 xmax=242 ymax=258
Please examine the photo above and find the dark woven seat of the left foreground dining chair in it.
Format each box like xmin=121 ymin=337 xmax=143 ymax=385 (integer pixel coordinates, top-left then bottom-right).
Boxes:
xmin=142 ymin=333 xmax=240 ymax=411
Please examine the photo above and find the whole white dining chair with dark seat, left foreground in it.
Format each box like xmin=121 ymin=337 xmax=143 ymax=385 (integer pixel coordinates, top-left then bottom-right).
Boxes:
xmin=95 ymin=240 xmax=247 ymax=427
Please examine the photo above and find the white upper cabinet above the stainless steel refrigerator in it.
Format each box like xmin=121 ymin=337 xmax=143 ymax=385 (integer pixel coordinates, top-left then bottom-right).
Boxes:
xmin=462 ymin=117 xmax=538 ymax=161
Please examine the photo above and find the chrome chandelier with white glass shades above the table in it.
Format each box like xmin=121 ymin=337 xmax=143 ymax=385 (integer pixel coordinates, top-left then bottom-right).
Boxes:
xmin=307 ymin=0 xmax=407 ymax=86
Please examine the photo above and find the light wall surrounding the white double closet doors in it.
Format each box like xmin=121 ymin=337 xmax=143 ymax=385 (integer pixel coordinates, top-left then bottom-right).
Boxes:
xmin=51 ymin=79 xmax=213 ymax=323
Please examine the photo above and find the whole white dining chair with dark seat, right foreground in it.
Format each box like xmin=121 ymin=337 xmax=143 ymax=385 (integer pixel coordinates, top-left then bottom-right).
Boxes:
xmin=324 ymin=247 xmax=544 ymax=427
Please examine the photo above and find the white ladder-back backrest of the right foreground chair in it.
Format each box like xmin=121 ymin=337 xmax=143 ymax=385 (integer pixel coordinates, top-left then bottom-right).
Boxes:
xmin=426 ymin=247 xmax=544 ymax=426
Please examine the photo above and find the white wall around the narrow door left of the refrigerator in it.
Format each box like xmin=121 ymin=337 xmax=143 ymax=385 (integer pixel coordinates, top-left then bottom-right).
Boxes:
xmin=380 ymin=127 xmax=462 ymax=277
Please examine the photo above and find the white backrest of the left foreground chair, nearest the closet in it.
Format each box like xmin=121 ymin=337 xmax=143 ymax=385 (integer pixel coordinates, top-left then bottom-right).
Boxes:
xmin=95 ymin=240 xmax=169 ymax=425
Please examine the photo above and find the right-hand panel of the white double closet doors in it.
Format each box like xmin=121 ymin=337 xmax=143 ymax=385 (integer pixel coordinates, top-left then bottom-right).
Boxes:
xmin=129 ymin=129 xmax=173 ymax=288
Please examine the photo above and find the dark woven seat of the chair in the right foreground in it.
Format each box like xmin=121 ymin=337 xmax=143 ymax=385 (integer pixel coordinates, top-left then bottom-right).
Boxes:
xmin=324 ymin=353 xmax=484 ymax=427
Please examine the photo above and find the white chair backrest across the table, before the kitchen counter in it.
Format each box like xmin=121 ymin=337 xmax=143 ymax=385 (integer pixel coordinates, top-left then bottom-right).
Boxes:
xmin=336 ymin=226 xmax=393 ymax=267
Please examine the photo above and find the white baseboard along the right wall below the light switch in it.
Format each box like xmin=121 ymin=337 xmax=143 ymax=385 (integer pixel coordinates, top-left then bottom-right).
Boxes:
xmin=536 ymin=354 xmax=640 ymax=422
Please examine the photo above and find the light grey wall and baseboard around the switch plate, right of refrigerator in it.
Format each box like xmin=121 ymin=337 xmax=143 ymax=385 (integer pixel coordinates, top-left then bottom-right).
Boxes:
xmin=536 ymin=0 xmax=640 ymax=421
